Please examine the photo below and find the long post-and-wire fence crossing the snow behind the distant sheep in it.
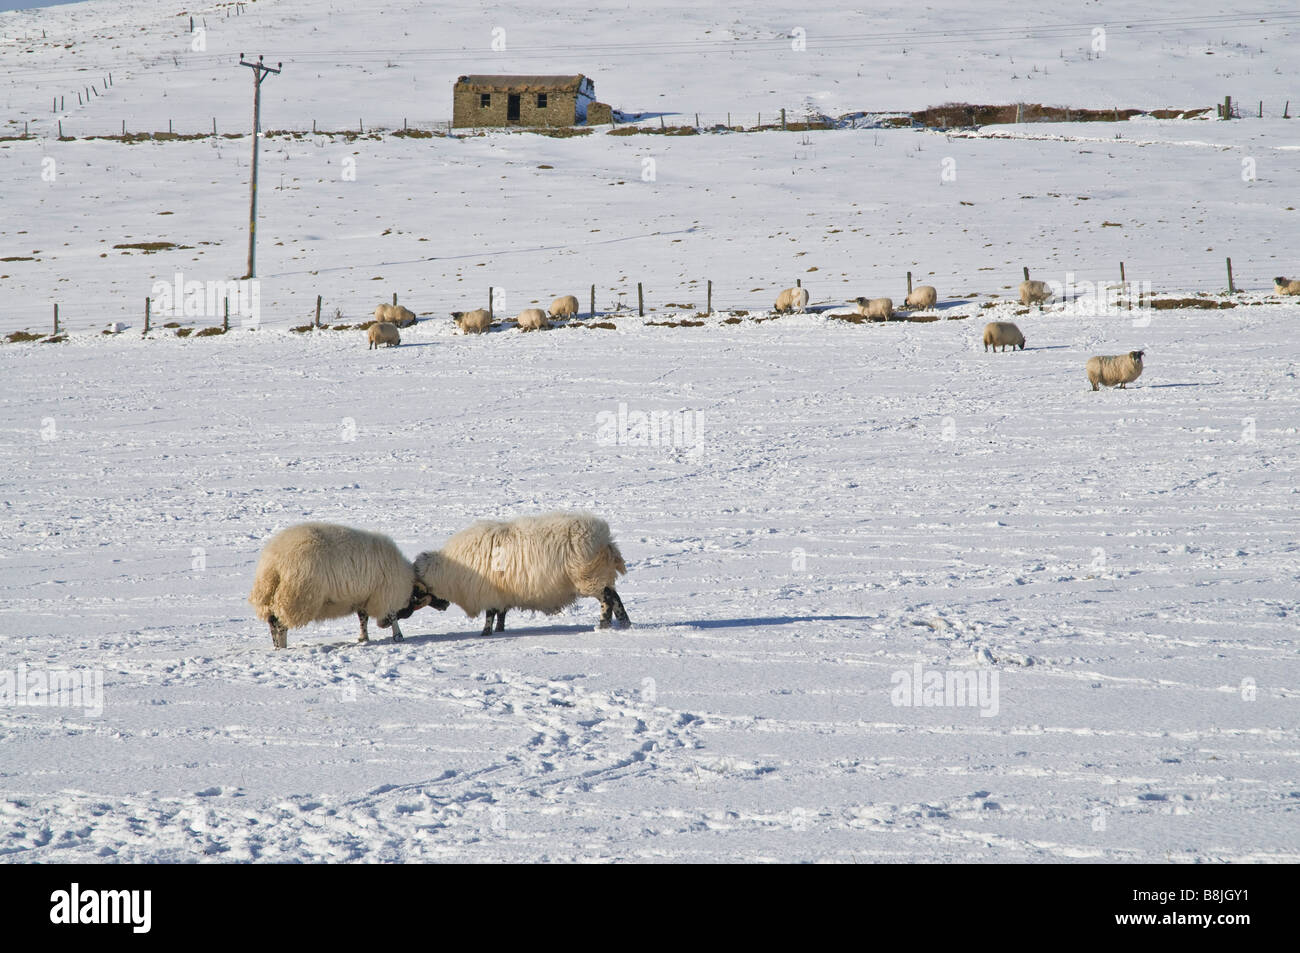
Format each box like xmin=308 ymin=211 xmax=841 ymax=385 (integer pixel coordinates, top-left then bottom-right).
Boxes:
xmin=0 ymin=257 xmax=1287 ymax=335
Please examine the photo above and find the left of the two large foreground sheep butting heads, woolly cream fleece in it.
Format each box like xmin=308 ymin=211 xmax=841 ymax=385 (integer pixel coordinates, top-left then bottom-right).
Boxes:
xmin=248 ymin=523 xmax=449 ymax=649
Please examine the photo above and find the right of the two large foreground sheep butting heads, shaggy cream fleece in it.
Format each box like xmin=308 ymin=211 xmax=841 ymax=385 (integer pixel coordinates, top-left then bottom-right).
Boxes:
xmin=415 ymin=512 xmax=631 ymax=636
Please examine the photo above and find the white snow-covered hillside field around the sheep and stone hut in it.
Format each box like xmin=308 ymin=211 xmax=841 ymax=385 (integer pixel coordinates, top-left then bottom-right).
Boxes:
xmin=0 ymin=0 xmax=1300 ymax=862
